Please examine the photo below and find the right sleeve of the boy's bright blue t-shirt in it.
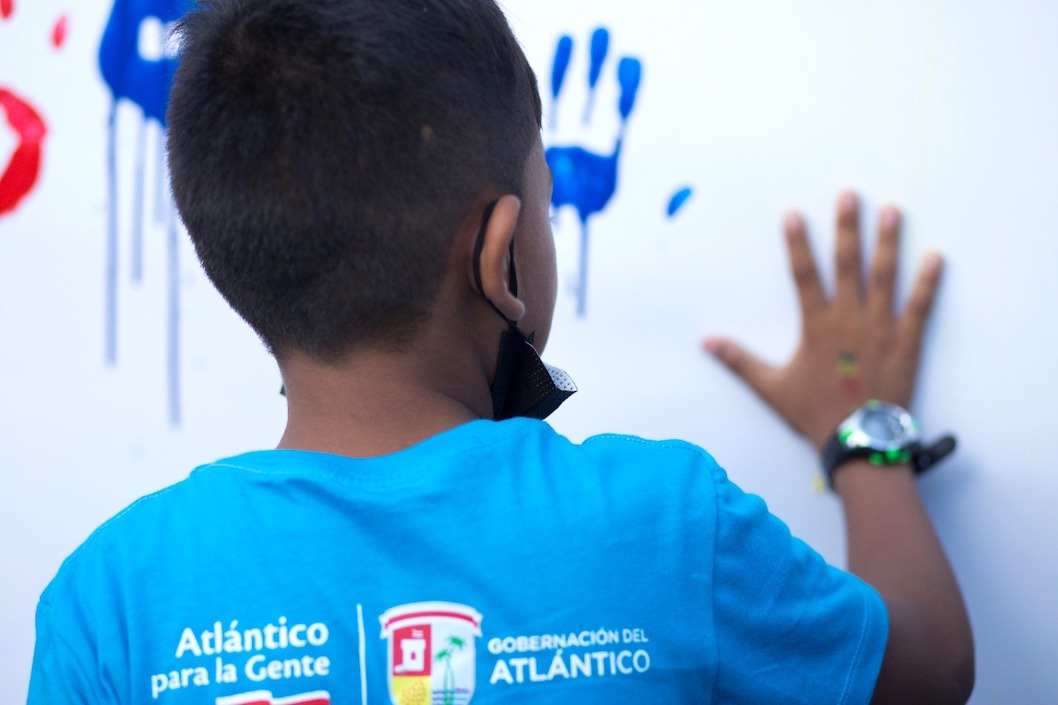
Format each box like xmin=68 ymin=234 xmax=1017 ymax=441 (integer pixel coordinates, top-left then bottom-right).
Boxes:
xmin=713 ymin=461 xmax=889 ymax=705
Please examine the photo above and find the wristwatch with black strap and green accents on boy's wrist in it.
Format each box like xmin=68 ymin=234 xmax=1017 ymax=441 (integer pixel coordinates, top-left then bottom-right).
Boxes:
xmin=823 ymin=399 xmax=955 ymax=487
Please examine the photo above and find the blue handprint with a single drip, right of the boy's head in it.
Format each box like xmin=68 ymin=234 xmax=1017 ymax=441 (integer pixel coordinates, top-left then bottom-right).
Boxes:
xmin=546 ymin=28 xmax=642 ymax=315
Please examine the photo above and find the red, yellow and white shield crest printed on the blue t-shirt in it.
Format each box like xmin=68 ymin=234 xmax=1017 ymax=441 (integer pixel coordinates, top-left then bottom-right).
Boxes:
xmin=379 ymin=602 xmax=481 ymax=705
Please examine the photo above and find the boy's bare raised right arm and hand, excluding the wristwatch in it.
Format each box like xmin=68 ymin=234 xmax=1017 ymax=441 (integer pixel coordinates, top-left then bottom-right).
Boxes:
xmin=706 ymin=194 xmax=973 ymax=704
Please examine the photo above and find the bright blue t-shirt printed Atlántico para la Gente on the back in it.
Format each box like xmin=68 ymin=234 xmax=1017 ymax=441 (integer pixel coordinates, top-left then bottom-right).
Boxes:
xmin=30 ymin=419 xmax=888 ymax=705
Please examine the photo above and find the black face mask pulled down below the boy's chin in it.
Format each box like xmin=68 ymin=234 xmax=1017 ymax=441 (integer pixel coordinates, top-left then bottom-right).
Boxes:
xmin=474 ymin=203 xmax=577 ymax=421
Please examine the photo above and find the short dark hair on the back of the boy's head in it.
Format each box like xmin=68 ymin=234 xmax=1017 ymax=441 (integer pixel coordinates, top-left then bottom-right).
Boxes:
xmin=168 ymin=0 xmax=540 ymax=361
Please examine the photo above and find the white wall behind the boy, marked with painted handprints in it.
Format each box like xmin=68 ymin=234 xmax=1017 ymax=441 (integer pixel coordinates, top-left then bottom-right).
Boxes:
xmin=0 ymin=0 xmax=1058 ymax=705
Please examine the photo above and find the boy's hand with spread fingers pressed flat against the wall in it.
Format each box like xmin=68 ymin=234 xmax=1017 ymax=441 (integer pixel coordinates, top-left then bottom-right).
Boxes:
xmin=705 ymin=193 xmax=942 ymax=451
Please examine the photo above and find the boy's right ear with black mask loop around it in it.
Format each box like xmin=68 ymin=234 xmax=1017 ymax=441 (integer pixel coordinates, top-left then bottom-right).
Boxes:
xmin=469 ymin=195 xmax=526 ymax=321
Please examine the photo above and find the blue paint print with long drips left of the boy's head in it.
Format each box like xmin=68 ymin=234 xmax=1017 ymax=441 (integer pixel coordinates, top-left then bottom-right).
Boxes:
xmin=99 ymin=0 xmax=191 ymax=426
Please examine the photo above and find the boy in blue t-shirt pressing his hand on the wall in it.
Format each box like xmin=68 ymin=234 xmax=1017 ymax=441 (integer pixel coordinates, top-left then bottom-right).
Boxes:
xmin=30 ymin=0 xmax=972 ymax=705
